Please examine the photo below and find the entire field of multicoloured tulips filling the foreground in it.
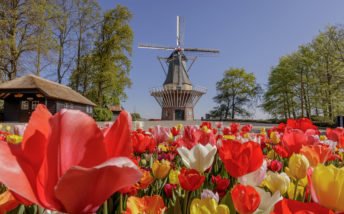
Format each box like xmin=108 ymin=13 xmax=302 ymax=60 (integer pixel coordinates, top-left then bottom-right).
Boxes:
xmin=0 ymin=105 xmax=344 ymax=214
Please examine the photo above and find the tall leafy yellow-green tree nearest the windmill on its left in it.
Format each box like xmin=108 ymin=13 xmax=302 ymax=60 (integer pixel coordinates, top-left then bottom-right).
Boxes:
xmin=88 ymin=5 xmax=133 ymax=106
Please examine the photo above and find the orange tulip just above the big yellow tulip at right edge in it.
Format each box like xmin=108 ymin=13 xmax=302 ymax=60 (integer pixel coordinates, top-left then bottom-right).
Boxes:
xmin=300 ymin=145 xmax=332 ymax=167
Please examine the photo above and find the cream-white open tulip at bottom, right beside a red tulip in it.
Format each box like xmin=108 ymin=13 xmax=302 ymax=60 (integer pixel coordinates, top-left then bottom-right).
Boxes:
xmin=254 ymin=187 xmax=283 ymax=214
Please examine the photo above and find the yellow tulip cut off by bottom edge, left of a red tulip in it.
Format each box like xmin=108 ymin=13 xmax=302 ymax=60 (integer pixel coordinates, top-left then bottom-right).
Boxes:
xmin=190 ymin=198 xmax=229 ymax=214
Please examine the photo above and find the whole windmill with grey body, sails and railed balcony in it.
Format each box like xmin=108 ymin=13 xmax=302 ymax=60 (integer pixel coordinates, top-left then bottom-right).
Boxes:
xmin=139 ymin=16 xmax=220 ymax=120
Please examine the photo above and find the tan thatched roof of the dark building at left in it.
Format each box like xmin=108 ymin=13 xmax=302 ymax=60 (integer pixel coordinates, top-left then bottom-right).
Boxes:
xmin=0 ymin=74 xmax=96 ymax=106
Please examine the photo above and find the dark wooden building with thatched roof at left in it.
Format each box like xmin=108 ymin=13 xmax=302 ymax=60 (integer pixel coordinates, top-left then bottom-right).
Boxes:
xmin=0 ymin=74 xmax=96 ymax=122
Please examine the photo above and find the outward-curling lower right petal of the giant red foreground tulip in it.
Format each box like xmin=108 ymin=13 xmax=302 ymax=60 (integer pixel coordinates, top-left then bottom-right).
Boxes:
xmin=55 ymin=157 xmax=142 ymax=213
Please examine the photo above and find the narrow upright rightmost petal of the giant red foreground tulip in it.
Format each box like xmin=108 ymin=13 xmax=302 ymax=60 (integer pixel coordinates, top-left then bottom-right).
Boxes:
xmin=104 ymin=111 xmax=133 ymax=158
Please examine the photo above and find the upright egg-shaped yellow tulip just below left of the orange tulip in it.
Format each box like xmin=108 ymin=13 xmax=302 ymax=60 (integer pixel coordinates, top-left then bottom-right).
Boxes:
xmin=288 ymin=153 xmax=309 ymax=180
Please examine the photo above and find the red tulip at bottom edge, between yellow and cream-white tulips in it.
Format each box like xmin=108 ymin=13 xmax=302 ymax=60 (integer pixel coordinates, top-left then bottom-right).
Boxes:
xmin=231 ymin=184 xmax=260 ymax=214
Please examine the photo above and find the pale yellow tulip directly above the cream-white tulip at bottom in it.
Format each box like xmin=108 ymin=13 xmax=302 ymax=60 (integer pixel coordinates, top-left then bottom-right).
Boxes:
xmin=264 ymin=171 xmax=290 ymax=195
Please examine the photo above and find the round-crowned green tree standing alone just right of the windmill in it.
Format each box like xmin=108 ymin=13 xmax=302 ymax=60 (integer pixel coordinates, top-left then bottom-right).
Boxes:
xmin=213 ymin=68 xmax=261 ymax=119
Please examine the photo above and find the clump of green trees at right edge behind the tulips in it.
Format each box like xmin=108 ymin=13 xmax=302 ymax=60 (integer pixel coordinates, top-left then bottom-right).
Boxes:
xmin=262 ymin=25 xmax=344 ymax=122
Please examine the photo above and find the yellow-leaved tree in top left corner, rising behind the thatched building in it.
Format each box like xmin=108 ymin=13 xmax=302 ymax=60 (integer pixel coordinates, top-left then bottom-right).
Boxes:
xmin=0 ymin=0 xmax=49 ymax=80
